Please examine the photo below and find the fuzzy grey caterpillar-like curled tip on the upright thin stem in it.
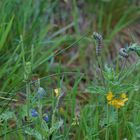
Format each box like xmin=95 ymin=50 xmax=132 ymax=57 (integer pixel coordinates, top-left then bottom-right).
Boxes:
xmin=93 ymin=32 xmax=103 ymax=55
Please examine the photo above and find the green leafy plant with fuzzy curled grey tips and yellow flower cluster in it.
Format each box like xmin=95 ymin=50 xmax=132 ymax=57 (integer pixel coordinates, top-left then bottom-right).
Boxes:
xmin=86 ymin=33 xmax=140 ymax=140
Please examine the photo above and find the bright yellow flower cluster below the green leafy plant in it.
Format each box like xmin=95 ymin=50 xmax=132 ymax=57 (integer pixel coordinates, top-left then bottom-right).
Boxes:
xmin=106 ymin=91 xmax=128 ymax=108
